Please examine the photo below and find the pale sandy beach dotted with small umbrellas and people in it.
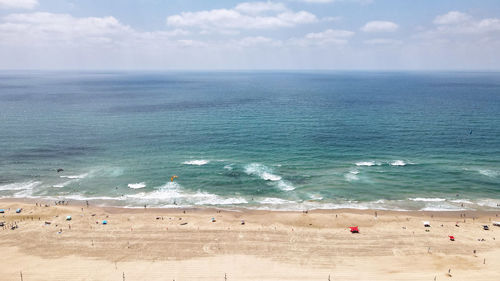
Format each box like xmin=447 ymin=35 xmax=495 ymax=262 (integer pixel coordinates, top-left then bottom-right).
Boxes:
xmin=0 ymin=199 xmax=500 ymax=280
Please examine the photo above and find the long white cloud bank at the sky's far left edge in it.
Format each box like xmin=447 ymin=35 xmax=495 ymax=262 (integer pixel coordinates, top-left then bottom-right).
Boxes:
xmin=0 ymin=12 xmax=189 ymax=47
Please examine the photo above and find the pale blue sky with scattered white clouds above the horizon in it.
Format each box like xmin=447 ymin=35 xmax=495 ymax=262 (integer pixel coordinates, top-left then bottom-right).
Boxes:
xmin=0 ymin=0 xmax=500 ymax=70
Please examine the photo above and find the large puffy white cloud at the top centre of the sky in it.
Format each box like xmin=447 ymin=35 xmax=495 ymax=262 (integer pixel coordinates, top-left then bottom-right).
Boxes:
xmin=167 ymin=2 xmax=318 ymax=31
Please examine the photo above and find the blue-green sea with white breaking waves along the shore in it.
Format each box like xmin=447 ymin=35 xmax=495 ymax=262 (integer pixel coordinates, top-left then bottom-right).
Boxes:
xmin=0 ymin=71 xmax=500 ymax=210
